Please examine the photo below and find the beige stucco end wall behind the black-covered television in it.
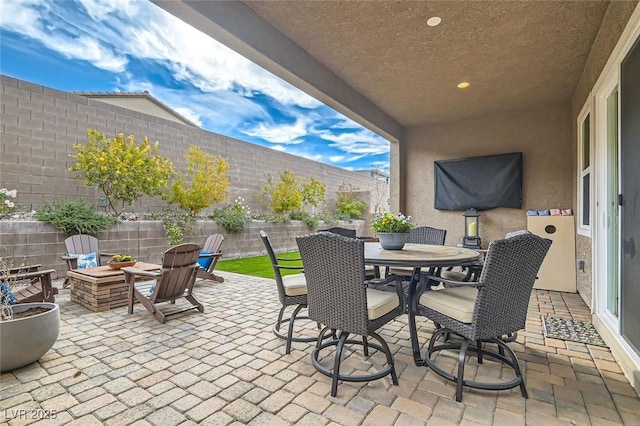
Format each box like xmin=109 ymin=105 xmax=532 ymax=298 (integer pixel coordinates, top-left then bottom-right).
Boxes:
xmin=401 ymin=105 xmax=575 ymax=246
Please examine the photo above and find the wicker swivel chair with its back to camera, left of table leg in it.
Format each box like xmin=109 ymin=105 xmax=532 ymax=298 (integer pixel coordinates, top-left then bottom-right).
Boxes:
xmin=296 ymin=232 xmax=403 ymax=396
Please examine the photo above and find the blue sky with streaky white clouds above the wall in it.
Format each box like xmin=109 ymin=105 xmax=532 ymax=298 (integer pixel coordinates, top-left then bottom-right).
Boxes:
xmin=0 ymin=0 xmax=389 ymax=171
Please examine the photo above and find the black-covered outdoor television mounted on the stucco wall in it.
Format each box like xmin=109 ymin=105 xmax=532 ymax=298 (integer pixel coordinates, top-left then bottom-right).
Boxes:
xmin=434 ymin=152 xmax=522 ymax=210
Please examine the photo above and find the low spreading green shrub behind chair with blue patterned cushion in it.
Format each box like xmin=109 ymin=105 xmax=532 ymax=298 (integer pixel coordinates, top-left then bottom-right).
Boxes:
xmin=35 ymin=200 xmax=118 ymax=236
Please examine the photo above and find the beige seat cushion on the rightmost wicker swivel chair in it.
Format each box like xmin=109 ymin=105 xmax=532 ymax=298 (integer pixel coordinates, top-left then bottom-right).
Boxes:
xmin=420 ymin=287 xmax=478 ymax=324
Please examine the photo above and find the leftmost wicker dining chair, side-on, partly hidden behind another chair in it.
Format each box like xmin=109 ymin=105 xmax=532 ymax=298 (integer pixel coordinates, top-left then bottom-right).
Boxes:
xmin=260 ymin=231 xmax=316 ymax=354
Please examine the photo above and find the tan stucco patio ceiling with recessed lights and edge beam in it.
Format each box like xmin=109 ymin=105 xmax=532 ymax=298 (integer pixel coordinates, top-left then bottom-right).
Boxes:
xmin=156 ymin=1 xmax=609 ymax=136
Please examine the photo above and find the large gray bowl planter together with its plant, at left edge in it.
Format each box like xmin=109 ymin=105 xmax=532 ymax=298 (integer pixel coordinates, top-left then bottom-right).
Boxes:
xmin=0 ymin=256 xmax=60 ymax=372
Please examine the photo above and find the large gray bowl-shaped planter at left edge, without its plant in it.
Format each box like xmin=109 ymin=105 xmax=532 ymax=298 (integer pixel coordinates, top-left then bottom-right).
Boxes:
xmin=0 ymin=302 xmax=60 ymax=371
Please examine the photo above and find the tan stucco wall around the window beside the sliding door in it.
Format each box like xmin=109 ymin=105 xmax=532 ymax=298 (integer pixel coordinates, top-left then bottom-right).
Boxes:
xmin=571 ymin=1 xmax=638 ymax=307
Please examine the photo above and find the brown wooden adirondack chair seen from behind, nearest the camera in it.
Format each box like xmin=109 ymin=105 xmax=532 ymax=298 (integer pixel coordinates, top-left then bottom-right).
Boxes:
xmin=122 ymin=244 xmax=204 ymax=323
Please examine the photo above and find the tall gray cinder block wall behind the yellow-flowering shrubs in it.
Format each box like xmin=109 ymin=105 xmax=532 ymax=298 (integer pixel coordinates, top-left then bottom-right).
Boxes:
xmin=0 ymin=76 xmax=379 ymax=213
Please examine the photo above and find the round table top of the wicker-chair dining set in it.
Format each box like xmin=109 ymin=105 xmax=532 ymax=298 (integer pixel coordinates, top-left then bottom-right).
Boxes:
xmin=364 ymin=243 xmax=482 ymax=267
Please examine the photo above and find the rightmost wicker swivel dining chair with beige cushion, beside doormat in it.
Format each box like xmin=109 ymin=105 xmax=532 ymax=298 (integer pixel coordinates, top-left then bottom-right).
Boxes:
xmin=416 ymin=234 xmax=551 ymax=401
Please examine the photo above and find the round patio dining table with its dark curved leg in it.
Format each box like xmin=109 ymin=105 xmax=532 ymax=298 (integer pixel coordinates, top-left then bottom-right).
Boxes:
xmin=364 ymin=243 xmax=482 ymax=366
